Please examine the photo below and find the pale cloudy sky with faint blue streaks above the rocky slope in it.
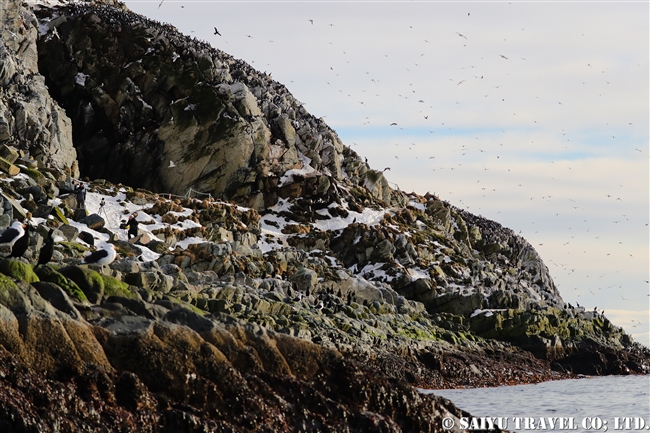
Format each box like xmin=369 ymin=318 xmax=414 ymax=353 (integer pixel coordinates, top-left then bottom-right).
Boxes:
xmin=119 ymin=0 xmax=650 ymax=346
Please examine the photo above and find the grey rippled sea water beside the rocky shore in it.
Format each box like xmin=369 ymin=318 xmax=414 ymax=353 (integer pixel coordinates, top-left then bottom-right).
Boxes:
xmin=420 ymin=375 xmax=650 ymax=433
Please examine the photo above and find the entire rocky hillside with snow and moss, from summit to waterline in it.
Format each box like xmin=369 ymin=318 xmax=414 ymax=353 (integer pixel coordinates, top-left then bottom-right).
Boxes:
xmin=0 ymin=0 xmax=650 ymax=432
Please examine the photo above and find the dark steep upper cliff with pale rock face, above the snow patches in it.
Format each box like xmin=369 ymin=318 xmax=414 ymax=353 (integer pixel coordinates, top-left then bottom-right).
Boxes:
xmin=38 ymin=4 xmax=391 ymax=209
